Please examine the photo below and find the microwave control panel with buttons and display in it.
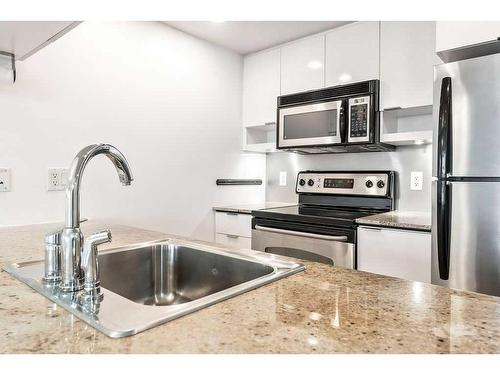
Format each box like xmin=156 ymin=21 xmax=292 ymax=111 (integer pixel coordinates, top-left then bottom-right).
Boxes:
xmin=347 ymin=96 xmax=370 ymax=142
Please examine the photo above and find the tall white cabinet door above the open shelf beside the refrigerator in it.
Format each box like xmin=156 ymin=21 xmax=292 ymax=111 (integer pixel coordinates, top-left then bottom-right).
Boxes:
xmin=380 ymin=21 xmax=439 ymax=110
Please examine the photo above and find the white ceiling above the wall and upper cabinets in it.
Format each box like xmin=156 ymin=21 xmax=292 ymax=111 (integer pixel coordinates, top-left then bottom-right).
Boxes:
xmin=165 ymin=21 xmax=351 ymax=55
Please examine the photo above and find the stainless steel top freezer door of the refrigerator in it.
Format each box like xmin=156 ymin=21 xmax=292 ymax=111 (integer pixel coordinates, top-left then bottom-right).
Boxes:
xmin=433 ymin=54 xmax=500 ymax=178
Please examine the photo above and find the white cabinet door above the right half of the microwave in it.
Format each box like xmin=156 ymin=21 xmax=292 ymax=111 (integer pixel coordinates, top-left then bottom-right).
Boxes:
xmin=325 ymin=21 xmax=379 ymax=86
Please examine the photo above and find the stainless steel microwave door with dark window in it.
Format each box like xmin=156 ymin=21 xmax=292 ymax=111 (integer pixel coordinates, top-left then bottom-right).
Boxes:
xmin=278 ymin=100 xmax=343 ymax=148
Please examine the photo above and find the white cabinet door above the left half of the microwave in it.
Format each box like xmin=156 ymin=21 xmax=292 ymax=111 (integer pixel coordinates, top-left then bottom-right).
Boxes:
xmin=281 ymin=35 xmax=325 ymax=95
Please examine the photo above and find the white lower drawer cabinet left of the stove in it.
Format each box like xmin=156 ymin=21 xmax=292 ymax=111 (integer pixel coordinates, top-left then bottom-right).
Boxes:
xmin=215 ymin=211 xmax=252 ymax=249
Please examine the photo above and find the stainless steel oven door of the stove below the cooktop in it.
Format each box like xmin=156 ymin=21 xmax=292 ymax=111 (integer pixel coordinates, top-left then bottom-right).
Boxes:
xmin=252 ymin=224 xmax=355 ymax=269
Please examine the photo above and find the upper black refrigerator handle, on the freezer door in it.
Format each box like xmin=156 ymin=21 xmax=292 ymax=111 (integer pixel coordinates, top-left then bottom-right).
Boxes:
xmin=437 ymin=77 xmax=452 ymax=178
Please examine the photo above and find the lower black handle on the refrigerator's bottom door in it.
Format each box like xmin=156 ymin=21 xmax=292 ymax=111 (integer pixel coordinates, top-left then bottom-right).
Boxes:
xmin=436 ymin=180 xmax=451 ymax=280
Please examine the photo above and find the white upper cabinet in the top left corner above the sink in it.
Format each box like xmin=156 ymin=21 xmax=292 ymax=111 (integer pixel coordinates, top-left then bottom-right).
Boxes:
xmin=0 ymin=21 xmax=79 ymax=60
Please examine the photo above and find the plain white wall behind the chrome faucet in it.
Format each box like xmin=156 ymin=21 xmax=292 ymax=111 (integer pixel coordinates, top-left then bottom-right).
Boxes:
xmin=0 ymin=22 xmax=266 ymax=239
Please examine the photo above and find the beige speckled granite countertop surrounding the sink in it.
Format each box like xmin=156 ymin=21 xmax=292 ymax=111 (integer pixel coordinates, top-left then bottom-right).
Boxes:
xmin=0 ymin=222 xmax=500 ymax=353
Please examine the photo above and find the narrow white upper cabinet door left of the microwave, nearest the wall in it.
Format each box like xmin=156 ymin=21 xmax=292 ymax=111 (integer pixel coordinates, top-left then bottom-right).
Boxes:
xmin=243 ymin=49 xmax=280 ymax=126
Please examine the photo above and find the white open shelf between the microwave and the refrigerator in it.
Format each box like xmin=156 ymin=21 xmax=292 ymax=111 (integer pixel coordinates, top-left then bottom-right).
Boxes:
xmin=380 ymin=106 xmax=433 ymax=146
